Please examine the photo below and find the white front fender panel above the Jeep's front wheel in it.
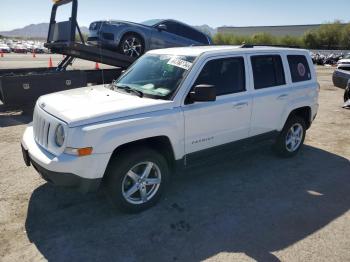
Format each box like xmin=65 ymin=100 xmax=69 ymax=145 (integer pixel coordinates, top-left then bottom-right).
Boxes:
xmin=69 ymin=109 xmax=184 ymax=159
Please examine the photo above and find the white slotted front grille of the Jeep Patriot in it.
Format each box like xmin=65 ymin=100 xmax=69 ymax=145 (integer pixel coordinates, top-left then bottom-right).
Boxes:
xmin=33 ymin=110 xmax=51 ymax=149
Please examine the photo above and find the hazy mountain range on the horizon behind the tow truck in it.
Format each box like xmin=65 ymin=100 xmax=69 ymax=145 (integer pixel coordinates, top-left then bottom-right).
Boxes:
xmin=0 ymin=23 xmax=216 ymax=38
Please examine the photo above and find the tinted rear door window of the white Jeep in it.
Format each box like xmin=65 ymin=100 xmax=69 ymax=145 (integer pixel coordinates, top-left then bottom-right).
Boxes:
xmin=251 ymin=55 xmax=286 ymax=89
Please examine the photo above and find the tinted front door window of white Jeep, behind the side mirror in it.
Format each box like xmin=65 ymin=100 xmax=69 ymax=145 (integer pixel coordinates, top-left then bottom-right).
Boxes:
xmin=195 ymin=57 xmax=245 ymax=96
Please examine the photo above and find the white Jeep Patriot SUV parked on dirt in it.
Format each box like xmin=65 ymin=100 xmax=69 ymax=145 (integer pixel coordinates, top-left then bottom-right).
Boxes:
xmin=22 ymin=46 xmax=319 ymax=212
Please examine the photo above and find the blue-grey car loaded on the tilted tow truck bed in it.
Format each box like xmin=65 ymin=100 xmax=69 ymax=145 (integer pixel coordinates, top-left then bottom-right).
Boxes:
xmin=88 ymin=19 xmax=212 ymax=57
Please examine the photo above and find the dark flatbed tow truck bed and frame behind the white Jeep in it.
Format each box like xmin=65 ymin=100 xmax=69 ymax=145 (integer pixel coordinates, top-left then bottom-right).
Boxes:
xmin=0 ymin=0 xmax=136 ymax=107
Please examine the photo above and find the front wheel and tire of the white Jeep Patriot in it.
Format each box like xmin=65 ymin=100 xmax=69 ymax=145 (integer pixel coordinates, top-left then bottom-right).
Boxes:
xmin=106 ymin=148 xmax=170 ymax=213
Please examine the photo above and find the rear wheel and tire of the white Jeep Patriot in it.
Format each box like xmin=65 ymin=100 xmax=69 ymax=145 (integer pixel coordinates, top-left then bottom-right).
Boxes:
xmin=273 ymin=115 xmax=306 ymax=157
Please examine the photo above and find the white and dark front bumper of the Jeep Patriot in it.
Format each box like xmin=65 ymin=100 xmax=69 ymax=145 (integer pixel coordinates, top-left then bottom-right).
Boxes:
xmin=22 ymin=127 xmax=110 ymax=193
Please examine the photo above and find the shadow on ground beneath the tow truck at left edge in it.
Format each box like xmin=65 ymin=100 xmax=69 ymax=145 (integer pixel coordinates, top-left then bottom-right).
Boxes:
xmin=0 ymin=105 xmax=33 ymax=127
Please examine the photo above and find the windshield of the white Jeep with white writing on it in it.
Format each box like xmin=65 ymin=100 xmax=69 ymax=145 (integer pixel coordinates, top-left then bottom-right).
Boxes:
xmin=114 ymin=54 xmax=195 ymax=99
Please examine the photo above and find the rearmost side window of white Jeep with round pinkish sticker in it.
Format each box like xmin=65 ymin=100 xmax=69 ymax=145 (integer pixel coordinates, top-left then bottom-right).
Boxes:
xmin=287 ymin=55 xmax=311 ymax=83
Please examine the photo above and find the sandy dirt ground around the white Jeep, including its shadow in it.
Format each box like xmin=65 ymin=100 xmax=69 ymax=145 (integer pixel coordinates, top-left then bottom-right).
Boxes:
xmin=0 ymin=62 xmax=350 ymax=261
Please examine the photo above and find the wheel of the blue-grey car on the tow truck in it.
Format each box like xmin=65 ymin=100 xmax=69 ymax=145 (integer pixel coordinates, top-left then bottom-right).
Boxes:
xmin=119 ymin=33 xmax=145 ymax=58
